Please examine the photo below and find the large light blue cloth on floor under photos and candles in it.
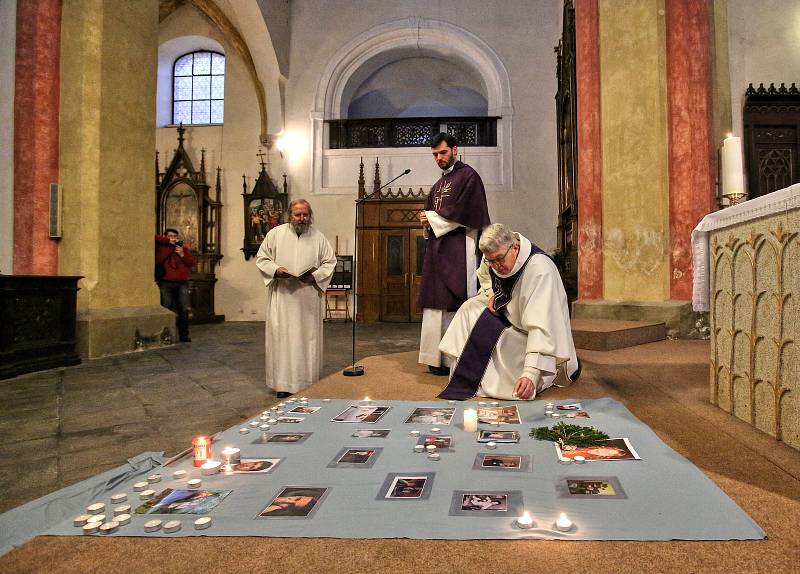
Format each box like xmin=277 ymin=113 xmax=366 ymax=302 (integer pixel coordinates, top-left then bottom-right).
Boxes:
xmin=7 ymin=398 xmax=766 ymax=540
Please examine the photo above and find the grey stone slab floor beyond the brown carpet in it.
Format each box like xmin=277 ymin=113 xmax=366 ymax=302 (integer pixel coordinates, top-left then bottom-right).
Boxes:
xmin=0 ymin=322 xmax=419 ymax=512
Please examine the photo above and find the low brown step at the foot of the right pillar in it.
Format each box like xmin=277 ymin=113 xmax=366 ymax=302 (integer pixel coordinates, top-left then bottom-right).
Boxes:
xmin=571 ymin=319 xmax=667 ymax=351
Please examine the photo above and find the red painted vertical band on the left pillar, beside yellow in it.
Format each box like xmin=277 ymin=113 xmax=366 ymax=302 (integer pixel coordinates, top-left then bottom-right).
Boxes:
xmin=14 ymin=0 xmax=61 ymax=275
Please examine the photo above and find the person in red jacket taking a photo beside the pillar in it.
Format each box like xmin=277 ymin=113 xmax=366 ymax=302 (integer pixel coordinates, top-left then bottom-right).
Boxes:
xmin=156 ymin=228 xmax=194 ymax=343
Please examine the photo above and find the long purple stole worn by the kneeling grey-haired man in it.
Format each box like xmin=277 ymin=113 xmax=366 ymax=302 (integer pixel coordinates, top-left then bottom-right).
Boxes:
xmin=438 ymin=244 xmax=544 ymax=401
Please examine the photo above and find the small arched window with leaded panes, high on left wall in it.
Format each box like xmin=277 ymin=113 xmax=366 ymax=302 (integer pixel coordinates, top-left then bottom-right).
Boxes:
xmin=172 ymin=51 xmax=225 ymax=125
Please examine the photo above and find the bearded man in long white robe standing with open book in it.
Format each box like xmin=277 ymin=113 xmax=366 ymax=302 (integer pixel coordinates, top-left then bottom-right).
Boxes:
xmin=256 ymin=199 xmax=336 ymax=398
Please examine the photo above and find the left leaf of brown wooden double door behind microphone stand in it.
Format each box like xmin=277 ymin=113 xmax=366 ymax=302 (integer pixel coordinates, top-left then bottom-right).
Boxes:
xmin=381 ymin=229 xmax=411 ymax=322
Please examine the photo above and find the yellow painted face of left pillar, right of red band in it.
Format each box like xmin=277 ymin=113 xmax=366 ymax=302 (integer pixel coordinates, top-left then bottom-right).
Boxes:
xmin=59 ymin=0 xmax=159 ymax=310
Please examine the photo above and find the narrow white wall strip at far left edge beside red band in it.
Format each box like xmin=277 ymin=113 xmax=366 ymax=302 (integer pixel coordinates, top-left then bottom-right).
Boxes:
xmin=0 ymin=0 xmax=17 ymax=275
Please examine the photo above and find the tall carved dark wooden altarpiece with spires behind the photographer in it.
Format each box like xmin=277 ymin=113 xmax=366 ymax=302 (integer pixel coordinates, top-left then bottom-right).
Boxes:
xmin=156 ymin=126 xmax=225 ymax=323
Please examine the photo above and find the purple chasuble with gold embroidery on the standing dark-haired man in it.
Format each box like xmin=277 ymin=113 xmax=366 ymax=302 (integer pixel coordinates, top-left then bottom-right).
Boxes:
xmin=419 ymin=161 xmax=490 ymax=311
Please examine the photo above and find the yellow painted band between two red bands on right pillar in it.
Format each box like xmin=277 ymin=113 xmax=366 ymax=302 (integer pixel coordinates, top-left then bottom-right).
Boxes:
xmin=600 ymin=0 xmax=669 ymax=301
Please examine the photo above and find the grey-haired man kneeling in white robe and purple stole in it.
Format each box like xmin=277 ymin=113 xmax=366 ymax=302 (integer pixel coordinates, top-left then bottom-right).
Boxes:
xmin=439 ymin=223 xmax=579 ymax=400
